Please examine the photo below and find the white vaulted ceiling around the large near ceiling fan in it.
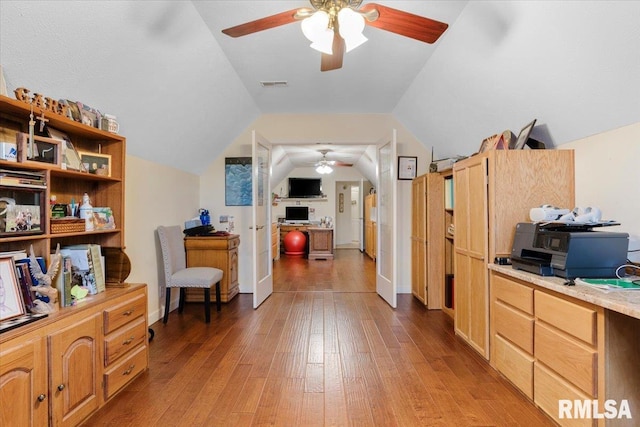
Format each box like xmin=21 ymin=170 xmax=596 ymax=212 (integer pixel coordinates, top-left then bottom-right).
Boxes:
xmin=0 ymin=0 xmax=640 ymax=177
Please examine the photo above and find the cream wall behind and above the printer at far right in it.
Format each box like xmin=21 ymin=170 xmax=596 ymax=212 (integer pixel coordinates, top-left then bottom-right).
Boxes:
xmin=559 ymin=122 xmax=640 ymax=262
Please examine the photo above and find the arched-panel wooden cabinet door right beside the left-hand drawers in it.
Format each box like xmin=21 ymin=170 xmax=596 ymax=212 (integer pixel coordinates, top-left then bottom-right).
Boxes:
xmin=49 ymin=314 xmax=101 ymax=426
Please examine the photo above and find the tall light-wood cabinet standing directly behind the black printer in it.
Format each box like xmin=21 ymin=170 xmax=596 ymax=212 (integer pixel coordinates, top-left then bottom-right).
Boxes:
xmin=453 ymin=150 xmax=575 ymax=359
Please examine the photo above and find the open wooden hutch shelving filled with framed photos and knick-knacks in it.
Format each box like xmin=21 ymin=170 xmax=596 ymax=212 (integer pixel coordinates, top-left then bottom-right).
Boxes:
xmin=0 ymin=96 xmax=126 ymax=259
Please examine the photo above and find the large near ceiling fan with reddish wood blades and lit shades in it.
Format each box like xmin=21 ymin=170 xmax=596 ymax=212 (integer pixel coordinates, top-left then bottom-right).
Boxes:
xmin=222 ymin=0 xmax=449 ymax=71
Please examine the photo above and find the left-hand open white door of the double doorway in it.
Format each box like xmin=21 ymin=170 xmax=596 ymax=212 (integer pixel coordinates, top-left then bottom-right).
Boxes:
xmin=251 ymin=131 xmax=273 ymax=308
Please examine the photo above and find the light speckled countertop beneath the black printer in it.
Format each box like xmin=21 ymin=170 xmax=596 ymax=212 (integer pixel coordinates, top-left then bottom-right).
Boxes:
xmin=489 ymin=264 xmax=640 ymax=319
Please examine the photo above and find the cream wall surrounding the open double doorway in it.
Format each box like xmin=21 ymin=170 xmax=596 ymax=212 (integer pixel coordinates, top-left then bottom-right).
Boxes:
xmin=200 ymin=114 xmax=431 ymax=293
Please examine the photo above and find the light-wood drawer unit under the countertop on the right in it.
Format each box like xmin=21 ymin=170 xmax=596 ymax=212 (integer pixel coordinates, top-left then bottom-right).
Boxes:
xmin=490 ymin=272 xmax=606 ymax=426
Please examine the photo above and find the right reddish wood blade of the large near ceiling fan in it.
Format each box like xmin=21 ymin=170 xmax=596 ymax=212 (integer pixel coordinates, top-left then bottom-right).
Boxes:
xmin=360 ymin=3 xmax=449 ymax=43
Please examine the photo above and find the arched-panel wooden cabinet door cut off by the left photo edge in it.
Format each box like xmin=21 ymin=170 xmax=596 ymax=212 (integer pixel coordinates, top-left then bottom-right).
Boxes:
xmin=0 ymin=338 xmax=49 ymax=426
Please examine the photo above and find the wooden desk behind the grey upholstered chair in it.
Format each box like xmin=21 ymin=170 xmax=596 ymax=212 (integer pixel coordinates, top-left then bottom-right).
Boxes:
xmin=184 ymin=234 xmax=240 ymax=302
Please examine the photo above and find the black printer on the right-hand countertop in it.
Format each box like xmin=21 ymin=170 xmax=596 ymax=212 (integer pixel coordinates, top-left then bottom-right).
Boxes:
xmin=511 ymin=222 xmax=629 ymax=279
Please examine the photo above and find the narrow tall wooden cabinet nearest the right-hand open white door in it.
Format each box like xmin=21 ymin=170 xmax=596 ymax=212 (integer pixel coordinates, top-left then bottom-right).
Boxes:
xmin=411 ymin=173 xmax=445 ymax=309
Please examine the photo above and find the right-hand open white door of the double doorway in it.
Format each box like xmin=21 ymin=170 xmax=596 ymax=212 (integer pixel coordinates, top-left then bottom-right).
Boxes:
xmin=376 ymin=129 xmax=398 ymax=308
